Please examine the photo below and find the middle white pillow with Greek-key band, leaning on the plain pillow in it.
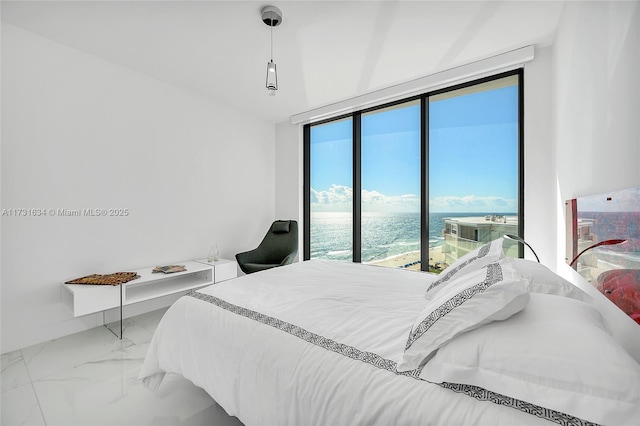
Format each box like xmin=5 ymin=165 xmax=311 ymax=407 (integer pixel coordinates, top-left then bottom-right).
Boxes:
xmin=397 ymin=263 xmax=529 ymax=371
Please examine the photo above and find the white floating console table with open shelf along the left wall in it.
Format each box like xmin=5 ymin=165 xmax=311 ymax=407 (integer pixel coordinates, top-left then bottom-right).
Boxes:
xmin=62 ymin=259 xmax=238 ymax=339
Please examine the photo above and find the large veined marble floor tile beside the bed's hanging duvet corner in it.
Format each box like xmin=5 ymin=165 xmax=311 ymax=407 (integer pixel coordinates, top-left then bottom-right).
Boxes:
xmin=34 ymin=361 xmax=238 ymax=426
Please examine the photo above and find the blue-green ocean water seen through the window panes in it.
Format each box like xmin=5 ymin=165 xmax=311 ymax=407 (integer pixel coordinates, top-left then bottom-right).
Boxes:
xmin=311 ymin=212 xmax=500 ymax=262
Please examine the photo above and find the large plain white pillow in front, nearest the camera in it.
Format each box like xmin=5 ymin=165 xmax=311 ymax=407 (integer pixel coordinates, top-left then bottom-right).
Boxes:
xmin=420 ymin=293 xmax=640 ymax=426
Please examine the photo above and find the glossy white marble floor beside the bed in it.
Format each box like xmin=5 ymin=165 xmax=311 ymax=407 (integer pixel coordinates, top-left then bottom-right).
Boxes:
xmin=0 ymin=310 xmax=242 ymax=426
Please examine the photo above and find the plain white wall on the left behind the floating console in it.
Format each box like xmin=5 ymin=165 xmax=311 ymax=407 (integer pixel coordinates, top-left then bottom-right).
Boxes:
xmin=0 ymin=23 xmax=276 ymax=353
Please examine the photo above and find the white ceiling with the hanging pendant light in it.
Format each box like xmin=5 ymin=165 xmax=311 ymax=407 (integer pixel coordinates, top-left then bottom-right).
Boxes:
xmin=1 ymin=0 xmax=562 ymax=123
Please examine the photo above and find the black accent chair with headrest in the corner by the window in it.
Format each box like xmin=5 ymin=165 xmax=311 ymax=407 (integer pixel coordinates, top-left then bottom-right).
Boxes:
xmin=236 ymin=220 xmax=298 ymax=274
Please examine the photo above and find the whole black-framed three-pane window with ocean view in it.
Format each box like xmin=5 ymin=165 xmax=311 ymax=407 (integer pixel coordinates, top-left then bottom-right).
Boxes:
xmin=304 ymin=70 xmax=523 ymax=272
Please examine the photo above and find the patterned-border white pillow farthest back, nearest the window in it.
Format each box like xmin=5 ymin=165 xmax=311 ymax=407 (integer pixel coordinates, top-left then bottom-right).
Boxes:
xmin=425 ymin=238 xmax=504 ymax=299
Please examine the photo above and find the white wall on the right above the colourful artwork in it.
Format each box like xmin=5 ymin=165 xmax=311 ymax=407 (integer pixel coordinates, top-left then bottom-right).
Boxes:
xmin=553 ymin=1 xmax=640 ymax=262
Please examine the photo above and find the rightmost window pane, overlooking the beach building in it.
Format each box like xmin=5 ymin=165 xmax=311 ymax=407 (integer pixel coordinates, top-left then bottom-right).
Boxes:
xmin=429 ymin=75 xmax=520 ymax=265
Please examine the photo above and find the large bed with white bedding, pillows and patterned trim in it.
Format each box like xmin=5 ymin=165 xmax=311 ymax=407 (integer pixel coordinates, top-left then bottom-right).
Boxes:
xmin=140 ymin=240 xmax=640 ymax=425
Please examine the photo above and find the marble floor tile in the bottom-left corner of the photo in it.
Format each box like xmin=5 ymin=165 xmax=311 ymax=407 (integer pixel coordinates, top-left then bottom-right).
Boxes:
xmin=0 ymin=383 xmax=46 ymax=426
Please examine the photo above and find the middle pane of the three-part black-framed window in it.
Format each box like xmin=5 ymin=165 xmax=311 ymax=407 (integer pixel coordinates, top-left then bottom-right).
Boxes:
xmin=360 ymin=100 xmax=420 ymax=268
